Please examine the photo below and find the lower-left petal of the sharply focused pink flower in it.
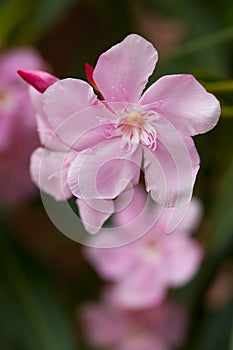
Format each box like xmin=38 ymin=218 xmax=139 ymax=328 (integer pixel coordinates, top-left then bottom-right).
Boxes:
xmin=68 ymin=139 xmax=142 ymax=200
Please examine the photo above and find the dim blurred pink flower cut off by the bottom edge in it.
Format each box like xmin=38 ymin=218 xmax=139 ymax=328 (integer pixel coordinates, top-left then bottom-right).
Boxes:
xmin=78 ymin=296 xmax=187 ymax=350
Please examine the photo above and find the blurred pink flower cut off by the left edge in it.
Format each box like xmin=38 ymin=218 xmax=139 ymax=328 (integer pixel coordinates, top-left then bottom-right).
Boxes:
xmin=0 ymin=48 xmax=46 ymax=203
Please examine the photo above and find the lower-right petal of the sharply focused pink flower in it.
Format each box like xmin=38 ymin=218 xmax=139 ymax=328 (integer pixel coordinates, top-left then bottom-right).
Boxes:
xmin=144 ymin=118 xmax=200 ymax=207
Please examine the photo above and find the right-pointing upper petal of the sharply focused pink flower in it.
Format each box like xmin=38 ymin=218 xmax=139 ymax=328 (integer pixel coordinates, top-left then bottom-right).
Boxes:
xmin=140 ymin=74 xmax=221 ymax=135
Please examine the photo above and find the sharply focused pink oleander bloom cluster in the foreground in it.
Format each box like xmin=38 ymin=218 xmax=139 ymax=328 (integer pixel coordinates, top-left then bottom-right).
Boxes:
xmin=18 ymin=34 xmax=220 ymax=233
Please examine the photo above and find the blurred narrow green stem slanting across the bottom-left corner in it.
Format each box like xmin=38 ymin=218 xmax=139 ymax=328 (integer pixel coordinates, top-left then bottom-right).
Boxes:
xmin=0 ymin=233 xmax=57 ymax=350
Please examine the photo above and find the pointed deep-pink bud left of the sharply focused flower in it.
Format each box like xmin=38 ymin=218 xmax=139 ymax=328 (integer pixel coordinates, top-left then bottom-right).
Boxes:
xmin=17 ymin=69 xmax=59 ymax=93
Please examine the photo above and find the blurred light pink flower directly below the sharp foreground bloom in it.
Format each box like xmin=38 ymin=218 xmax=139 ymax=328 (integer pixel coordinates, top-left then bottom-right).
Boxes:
xmin=84 ymin=189 xmax=203 ymax=308
